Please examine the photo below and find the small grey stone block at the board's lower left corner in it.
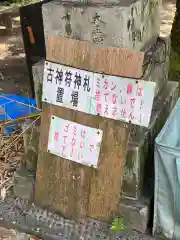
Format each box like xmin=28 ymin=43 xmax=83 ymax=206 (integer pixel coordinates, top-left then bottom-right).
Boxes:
xmin=13 ymin=167 xmax=35 ymax=201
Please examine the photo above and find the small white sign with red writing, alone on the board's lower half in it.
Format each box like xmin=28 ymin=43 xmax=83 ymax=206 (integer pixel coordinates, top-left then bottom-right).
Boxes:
xmin=48 ymin=116 xmax=103 ymax=168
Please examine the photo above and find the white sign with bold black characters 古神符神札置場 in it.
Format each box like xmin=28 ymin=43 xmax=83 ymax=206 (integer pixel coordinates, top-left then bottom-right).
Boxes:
xmin=42 ymin=62 xmax=93 ymax=113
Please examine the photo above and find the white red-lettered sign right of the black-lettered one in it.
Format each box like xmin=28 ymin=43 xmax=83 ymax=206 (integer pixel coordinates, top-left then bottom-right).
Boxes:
xmin=90 ymin=73 xmax=156 ymax=127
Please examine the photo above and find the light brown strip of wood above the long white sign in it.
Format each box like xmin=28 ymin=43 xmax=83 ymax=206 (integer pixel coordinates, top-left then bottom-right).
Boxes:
xmin=46 ymin=36 xmax=144 ymax=78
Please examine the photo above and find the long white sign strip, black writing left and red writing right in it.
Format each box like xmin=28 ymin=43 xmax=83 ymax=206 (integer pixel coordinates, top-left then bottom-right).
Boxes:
xmin=42 ymin=62 xmax=156 ymax=127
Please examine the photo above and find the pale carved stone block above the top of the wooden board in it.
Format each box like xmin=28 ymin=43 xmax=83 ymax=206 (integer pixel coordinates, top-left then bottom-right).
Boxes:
xmin=42 ymin=0 xmax=161 ymax=50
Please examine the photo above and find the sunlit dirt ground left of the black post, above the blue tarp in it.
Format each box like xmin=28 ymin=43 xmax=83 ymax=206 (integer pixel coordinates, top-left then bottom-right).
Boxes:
xmin=0 ymin=15 xmax=30 ymax=94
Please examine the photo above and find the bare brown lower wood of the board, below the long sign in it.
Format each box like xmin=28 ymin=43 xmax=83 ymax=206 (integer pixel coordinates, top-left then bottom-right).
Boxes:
xmin=35 ymin=104 xmax=129 ymax=221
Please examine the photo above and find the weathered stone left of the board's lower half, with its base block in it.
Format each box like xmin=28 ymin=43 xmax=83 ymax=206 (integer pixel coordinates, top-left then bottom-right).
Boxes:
xmin=13 ymin=119 xmax=40 ymax=201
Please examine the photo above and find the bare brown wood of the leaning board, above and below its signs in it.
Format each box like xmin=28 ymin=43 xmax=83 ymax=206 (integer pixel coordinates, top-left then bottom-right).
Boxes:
xmin=35 ymin=37 xmax=131 ymax=221
